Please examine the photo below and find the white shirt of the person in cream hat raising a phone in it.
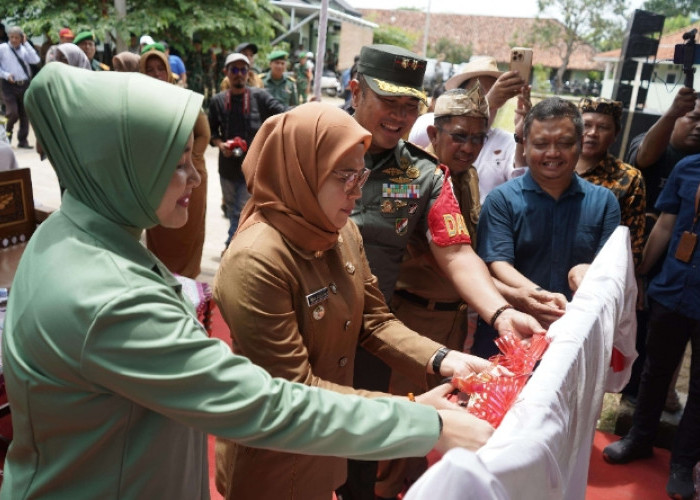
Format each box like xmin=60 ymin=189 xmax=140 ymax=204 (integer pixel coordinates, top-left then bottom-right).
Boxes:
xmin=474 ymin=128 xmax=527 ymax=205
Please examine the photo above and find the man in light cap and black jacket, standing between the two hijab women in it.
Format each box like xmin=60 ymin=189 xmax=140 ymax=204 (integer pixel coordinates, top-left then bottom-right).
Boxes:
xmin=209 ymin=53 xmax=286 ymax=246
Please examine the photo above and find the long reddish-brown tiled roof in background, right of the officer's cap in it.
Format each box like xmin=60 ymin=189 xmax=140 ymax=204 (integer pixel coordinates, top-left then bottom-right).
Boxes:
xmin=360 ymin=9 xmax=603 ymax=71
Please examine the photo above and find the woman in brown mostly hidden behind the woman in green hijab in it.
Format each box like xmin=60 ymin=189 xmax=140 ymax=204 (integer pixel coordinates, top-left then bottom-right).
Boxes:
xmin=139 ymin=49 xmax=211 ymax=279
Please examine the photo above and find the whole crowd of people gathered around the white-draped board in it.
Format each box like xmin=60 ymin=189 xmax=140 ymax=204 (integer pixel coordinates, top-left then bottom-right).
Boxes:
xmin=0 ymin=19 xmax=700 ymax=500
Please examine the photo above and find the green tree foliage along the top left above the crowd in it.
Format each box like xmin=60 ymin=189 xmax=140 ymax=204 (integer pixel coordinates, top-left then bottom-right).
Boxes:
xmin=4 ymin=0 xmax=285 ymax=55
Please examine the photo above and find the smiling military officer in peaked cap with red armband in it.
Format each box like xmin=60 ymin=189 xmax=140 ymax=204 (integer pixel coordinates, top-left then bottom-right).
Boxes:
xmin=339 ymin=45 xmax=544 ymax=500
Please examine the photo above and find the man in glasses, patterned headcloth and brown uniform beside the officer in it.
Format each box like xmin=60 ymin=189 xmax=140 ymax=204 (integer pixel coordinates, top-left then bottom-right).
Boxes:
xmin=375 ymin=88 xmax=489 ymax=498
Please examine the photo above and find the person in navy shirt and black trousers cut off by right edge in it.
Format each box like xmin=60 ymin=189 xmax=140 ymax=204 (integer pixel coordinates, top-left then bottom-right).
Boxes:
xmin=603 ymin=155 xmax=700 ymax=499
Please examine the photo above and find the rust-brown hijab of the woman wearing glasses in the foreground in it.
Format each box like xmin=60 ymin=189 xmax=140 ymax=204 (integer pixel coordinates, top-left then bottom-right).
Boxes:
xmin=239 ymin=103 xmax=371 ymax=251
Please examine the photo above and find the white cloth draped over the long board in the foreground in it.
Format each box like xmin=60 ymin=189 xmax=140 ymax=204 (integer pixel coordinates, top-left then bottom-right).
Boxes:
xmin=405 ymin=226 xmax=636 ymax=500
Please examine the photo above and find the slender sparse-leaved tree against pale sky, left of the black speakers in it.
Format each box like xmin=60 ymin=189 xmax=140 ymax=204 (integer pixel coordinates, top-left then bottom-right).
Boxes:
xmin=535 ymin=0 xmax=627 ymax=93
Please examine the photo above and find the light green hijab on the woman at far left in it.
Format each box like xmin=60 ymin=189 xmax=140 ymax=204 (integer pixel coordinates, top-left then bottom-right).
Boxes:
xmin=24 ymin=64 xmax=202 ymax=228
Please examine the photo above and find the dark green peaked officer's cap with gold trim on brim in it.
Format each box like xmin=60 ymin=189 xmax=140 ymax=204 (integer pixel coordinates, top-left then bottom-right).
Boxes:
xmin=357 ymin=45 xmax=427 ymax=102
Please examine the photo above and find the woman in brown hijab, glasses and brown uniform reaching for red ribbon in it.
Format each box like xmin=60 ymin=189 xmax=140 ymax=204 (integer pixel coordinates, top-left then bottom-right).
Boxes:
xmin=214 ymin=103 xmax=492 ymax=500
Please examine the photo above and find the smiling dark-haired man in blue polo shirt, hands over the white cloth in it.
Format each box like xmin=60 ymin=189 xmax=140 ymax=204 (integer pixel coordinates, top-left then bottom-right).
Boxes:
xmin=472 ymin=97 xmax=620 ymax=356
